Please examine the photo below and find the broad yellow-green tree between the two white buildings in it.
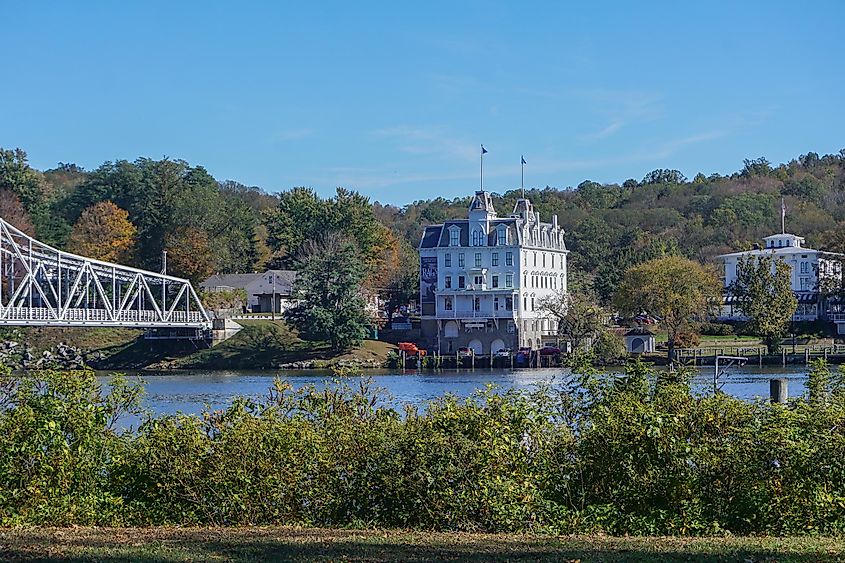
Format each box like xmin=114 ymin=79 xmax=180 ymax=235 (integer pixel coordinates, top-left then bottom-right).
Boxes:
xmin=614 ymin=256 xmax=721 ymax=362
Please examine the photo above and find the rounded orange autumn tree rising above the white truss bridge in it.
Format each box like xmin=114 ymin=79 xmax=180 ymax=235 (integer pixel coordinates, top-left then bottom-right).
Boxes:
xmin=68 ymin=201 xmax=137 ymax=262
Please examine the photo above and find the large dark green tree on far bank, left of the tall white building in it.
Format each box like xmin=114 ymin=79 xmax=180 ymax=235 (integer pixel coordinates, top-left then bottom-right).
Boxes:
xmin=285 ymin=233 xmax=371 ymax=352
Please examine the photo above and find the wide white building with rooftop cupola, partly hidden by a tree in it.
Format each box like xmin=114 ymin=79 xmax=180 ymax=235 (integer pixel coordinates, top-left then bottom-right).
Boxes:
xmin=717 ymin=233 xmax=845 ymax=334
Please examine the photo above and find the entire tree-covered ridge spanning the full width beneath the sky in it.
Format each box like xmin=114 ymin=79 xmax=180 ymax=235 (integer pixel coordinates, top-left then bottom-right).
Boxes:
xmin=0 ymin=149 xmax=845 ymax=299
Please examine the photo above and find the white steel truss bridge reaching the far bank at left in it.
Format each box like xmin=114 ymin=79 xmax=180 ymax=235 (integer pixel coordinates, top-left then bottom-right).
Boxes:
xmin=0 ymin=218 xmax=211 ymax=330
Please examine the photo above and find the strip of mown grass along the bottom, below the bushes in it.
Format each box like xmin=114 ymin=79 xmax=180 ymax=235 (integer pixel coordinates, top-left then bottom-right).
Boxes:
xmin=0 ymin=527 xmax=845 ymax=562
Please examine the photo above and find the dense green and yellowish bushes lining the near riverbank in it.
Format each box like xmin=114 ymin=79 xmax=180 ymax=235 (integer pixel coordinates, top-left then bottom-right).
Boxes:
xmin=0 ymin=363 xmax=845 ymax=535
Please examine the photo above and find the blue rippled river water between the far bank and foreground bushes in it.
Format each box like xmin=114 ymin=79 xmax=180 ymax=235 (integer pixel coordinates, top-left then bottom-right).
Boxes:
xmin=95 ymin=366 xmax=806 ymax=415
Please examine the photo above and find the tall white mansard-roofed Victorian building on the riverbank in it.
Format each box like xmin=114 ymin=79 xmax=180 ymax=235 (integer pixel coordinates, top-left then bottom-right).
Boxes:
xmin=419 ymin=191 xmax=568 ymax=354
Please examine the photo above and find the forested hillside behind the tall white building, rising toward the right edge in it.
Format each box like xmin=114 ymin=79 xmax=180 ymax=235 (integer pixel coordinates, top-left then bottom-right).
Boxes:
xmin=375 ymin=149 xmax=845 ymax=300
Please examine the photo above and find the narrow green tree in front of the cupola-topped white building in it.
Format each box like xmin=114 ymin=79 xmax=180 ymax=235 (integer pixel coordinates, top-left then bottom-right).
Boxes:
xmin=728 ymin=255 xmax=798 ymax=354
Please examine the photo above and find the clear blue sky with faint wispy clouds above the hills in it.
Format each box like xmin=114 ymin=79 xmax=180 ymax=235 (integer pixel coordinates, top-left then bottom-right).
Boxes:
xmin=0 ymin=1 xmax=845 ymax=204
